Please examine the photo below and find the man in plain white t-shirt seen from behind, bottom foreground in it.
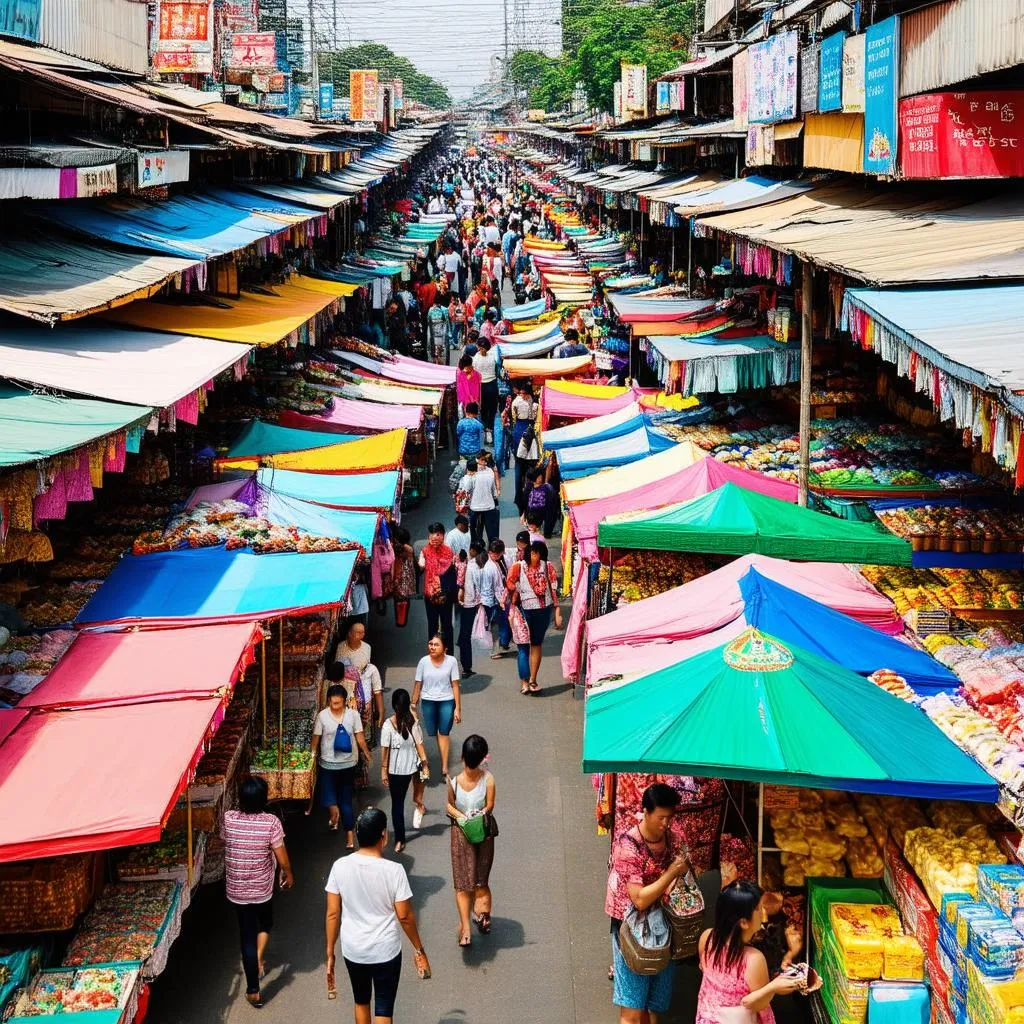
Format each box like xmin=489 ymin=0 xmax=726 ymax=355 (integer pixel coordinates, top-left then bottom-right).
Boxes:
xmin=326 ymin=807 xmax=430 ymax=1024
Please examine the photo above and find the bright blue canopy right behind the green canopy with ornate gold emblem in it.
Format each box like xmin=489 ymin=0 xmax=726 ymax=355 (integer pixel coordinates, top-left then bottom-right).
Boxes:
xmin=739 ymin=568 xmax=959 ymax=693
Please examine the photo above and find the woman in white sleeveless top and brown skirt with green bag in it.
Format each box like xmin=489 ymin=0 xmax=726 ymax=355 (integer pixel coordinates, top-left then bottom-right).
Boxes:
xmin=447 ymin=733 xmax=497 ymax=946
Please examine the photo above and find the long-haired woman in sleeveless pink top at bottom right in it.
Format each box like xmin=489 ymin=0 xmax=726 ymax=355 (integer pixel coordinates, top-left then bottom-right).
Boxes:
xmin=696 ymin=881 xmax=801 ymax=1024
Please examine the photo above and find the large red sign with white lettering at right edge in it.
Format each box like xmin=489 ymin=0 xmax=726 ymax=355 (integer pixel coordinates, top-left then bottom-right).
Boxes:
xmin=899 ymin=90 xmax=1024 ymax=178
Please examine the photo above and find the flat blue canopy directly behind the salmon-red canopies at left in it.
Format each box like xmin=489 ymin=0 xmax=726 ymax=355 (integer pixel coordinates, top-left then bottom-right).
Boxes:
xmin=77 ymin=547 xmax=356 ymax=625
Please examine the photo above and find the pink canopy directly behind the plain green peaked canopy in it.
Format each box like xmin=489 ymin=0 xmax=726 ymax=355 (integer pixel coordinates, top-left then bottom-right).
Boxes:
xmin=569 ymin=459 xmax=799 ymax=561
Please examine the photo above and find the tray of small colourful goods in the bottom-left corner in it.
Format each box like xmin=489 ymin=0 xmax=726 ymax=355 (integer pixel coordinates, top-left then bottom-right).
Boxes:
xmin=10 ymin=964 xmax=139 ymax=1020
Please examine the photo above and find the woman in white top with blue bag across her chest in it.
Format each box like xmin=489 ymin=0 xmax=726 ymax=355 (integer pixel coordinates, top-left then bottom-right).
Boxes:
xmin=312 ymin=683 xmax=370 ymax=850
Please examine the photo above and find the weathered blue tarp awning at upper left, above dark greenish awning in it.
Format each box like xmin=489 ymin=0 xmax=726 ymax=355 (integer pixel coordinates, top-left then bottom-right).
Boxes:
xmin=29 ymin=195 xmax=316 ymax=259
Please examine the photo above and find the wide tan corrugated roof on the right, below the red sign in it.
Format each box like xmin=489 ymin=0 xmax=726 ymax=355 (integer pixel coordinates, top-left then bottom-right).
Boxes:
xmin=700 ymin=185 xmax=1024 ymax=285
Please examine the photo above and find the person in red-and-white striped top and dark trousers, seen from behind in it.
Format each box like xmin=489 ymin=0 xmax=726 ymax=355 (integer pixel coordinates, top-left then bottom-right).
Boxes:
xmin=220 ymin=778 xmax=295 ymax=1007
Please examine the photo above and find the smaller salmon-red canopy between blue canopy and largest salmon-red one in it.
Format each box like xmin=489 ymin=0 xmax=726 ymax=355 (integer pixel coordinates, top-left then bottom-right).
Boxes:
xmin=19 ymin=623 xmax=259 ymax=712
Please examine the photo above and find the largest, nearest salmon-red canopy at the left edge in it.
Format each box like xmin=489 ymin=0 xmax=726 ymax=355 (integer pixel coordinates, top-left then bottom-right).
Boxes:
xmin=0 ymin=697 xmax=222 ymax=862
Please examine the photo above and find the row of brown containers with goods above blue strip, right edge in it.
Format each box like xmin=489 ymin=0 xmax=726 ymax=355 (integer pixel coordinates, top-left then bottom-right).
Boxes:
xmin=878 ymin=505 xmax=1024 ymax=555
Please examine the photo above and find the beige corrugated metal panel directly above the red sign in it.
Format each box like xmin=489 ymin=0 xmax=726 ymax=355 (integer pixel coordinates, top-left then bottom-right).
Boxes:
xmin=899 ymin=0 xmax=1024 ymax=96
